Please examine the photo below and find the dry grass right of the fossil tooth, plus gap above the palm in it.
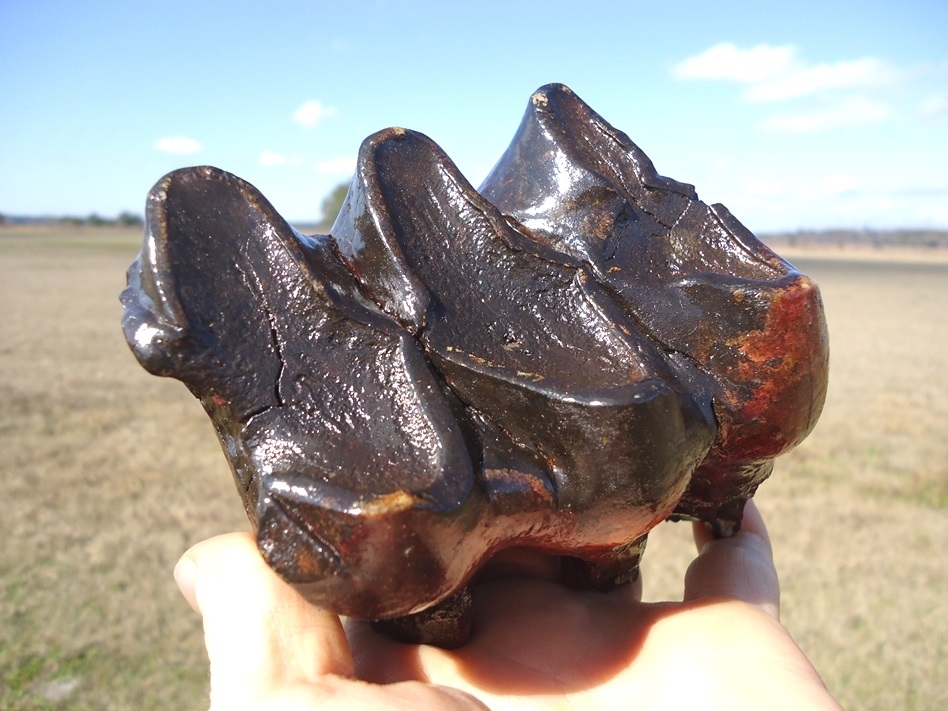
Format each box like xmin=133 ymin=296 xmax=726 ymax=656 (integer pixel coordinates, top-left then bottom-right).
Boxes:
xmin=645 ymin=255 xmax=948 ymax=709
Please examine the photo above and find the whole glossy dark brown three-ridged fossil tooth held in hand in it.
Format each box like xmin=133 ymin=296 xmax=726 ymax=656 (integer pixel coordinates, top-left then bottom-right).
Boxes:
xmin=122 ymin=85 xmax=828 ymax=646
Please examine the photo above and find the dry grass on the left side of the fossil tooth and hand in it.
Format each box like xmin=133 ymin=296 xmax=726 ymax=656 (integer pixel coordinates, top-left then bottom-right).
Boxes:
xmin=0 ymin=230 xmax=247 ymax=709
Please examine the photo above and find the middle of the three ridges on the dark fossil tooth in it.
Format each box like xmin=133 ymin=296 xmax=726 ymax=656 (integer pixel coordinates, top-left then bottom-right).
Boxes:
xmin=334 ymin=129 xmax=713 ymax=510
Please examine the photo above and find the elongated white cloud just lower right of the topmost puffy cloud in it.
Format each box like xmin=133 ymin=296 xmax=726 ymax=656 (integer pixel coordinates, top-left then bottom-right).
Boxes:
xmin=744 ymin=57 xmax=896 ymax=101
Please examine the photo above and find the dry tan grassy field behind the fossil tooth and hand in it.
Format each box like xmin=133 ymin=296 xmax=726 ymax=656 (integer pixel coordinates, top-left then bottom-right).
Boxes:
xmin=0 ymin=228 xmax=948 ymax=710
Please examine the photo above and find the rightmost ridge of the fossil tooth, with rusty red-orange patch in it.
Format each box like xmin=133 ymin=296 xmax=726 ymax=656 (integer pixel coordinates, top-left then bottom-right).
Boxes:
xmin=480 ymin=84 xmax=828 ymax=532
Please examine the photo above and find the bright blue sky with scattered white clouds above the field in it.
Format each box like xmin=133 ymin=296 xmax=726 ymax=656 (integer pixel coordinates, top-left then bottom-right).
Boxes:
xmin=0 ymin=0 xmax=948 ymax=232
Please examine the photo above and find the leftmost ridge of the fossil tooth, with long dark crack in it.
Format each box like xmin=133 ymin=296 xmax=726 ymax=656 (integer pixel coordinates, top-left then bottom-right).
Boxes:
xmin=123 ymin=167 xmax=483 ymax=616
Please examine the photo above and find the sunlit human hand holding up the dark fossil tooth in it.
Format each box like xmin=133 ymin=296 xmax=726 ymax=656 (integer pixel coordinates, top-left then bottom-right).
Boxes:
xmin=175 ymin=501 xmax=840 ymax=711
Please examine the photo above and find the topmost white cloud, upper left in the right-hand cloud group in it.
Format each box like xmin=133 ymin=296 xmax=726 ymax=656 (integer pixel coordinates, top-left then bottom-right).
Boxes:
xmin=674 ymin=42 xmax=796 ymax=84
